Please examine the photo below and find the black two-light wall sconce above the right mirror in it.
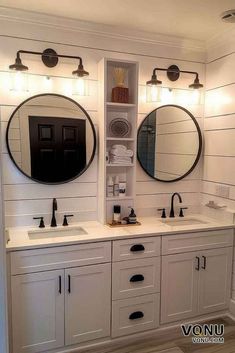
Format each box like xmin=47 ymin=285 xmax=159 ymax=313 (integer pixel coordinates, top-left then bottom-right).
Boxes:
xmin=146 ymin=65 xmax=203 ymax=104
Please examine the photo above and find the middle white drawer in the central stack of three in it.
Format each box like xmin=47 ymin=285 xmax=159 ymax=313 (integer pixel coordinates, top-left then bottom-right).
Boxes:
xmin=112 ymin=257 xmax=160 ymax=299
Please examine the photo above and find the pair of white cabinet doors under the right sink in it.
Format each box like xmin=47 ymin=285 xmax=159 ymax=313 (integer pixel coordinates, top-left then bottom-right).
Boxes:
xmin=161 ymin=247 xmax=232 ymax=323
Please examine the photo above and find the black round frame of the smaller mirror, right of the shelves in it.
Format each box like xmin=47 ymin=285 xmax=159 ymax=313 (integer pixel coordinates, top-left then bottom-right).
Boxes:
xmin=137 ymin=104 xmax=202 ymax=183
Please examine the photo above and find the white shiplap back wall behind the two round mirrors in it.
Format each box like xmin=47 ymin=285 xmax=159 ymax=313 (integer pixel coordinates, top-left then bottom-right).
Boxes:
xmin=0 ymin=11 xmax=204 ymax=226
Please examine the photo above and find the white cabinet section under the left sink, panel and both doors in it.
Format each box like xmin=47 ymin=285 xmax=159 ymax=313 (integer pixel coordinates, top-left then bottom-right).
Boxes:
xmin=11 ymin=242 xmax=111 ymax=353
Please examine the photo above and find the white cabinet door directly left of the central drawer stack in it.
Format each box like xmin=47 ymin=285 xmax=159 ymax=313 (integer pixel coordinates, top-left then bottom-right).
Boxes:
xmin=65 ymin=264 xmax=111 ymax=345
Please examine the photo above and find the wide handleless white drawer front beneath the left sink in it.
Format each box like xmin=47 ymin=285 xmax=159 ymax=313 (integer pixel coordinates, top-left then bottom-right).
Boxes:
xmin=11 ymin=242 xmax=111 ymax=275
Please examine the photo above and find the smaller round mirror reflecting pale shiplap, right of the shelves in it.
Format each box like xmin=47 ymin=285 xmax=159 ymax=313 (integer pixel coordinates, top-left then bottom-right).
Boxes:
xmin=137 ymin=105 xmax=202 ymax=182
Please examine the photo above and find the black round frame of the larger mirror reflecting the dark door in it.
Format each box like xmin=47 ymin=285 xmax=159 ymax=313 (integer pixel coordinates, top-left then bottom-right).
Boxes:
xmin=6 ymin=93 xmax=97 ymax=185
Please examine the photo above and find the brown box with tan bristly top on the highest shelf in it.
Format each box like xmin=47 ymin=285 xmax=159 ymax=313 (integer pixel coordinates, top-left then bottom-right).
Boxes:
xmin=112 ymin=67 xmax=129 ymax=103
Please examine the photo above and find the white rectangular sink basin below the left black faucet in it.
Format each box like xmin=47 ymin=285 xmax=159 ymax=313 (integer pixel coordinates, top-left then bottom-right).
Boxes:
xmin=28 ymin=227 xmax=87 ymax=239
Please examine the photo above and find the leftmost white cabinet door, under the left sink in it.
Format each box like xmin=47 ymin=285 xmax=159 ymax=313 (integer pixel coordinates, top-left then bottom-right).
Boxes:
xmin=11 ymin=270 xmax=64 ymax=353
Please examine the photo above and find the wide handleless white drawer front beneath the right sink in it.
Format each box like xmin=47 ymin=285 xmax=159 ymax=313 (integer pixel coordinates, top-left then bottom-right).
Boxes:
xmin=162 ymin=229 xmax=233 ymax=255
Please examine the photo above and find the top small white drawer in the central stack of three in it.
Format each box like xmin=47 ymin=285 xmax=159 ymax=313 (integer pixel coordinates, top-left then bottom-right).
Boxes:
xmin=113 ymin=237 xmax=161 ymax=261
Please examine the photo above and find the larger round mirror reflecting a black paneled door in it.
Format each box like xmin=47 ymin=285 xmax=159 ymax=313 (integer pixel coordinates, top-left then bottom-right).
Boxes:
xmin=6 ymin=94 xmax=96 ymax=184
